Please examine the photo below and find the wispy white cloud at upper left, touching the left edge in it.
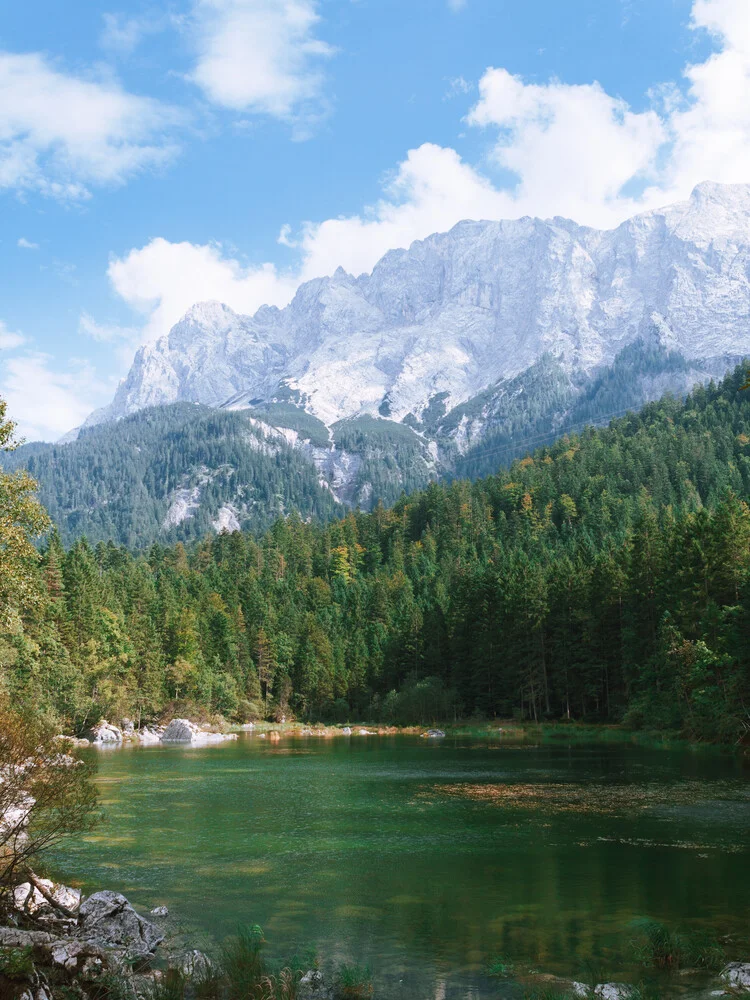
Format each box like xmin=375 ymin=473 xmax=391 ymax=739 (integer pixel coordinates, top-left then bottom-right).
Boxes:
xmin=0 ymin=52 xmax=182 ymax=199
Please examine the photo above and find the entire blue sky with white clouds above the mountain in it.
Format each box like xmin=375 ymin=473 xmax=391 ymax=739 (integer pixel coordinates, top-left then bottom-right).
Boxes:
xmin=0 ymin=0 xmax=750 ymax=440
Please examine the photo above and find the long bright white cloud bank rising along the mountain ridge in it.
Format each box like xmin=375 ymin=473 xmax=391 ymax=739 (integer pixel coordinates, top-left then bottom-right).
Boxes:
xmin=103 ymin=0 xmax=750 ymax=337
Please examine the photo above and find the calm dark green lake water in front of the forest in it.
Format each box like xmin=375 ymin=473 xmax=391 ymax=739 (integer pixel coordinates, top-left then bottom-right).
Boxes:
xmin=50 ymin=735 xmax=750 ymax=1000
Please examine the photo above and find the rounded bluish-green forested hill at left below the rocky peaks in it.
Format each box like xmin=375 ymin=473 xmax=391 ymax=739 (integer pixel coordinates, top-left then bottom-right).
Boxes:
xmin=2 ymin=403 xmax=341 ymax=548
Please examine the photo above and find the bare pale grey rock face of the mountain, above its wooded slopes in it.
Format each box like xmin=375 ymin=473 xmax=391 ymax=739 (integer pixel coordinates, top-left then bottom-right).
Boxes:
xmin=95 ymin=184 xmax=750 ymax=434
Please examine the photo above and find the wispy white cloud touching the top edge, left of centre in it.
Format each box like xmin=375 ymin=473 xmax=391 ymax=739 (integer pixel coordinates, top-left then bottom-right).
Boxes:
xmin=190 ymin=0 xmax=334 ymax=127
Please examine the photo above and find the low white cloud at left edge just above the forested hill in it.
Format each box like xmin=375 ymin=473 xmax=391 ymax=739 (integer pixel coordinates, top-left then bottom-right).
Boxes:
xmin=0 ymin=351 xmax=113 ymax=441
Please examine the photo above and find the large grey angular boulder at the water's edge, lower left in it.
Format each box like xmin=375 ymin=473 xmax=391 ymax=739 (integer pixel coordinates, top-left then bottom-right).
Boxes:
xmin=78 ymin=889 xmax=164 ymax=959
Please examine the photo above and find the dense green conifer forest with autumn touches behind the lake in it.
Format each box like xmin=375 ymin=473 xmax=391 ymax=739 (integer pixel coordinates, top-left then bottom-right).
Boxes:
xmin=0 ymin=369 xmax=750 ymax=740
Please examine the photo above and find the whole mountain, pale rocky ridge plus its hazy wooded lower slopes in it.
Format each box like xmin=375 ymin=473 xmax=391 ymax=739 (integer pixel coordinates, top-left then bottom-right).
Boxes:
xmin=4 ymin=183 xmax=750 ymax=544
